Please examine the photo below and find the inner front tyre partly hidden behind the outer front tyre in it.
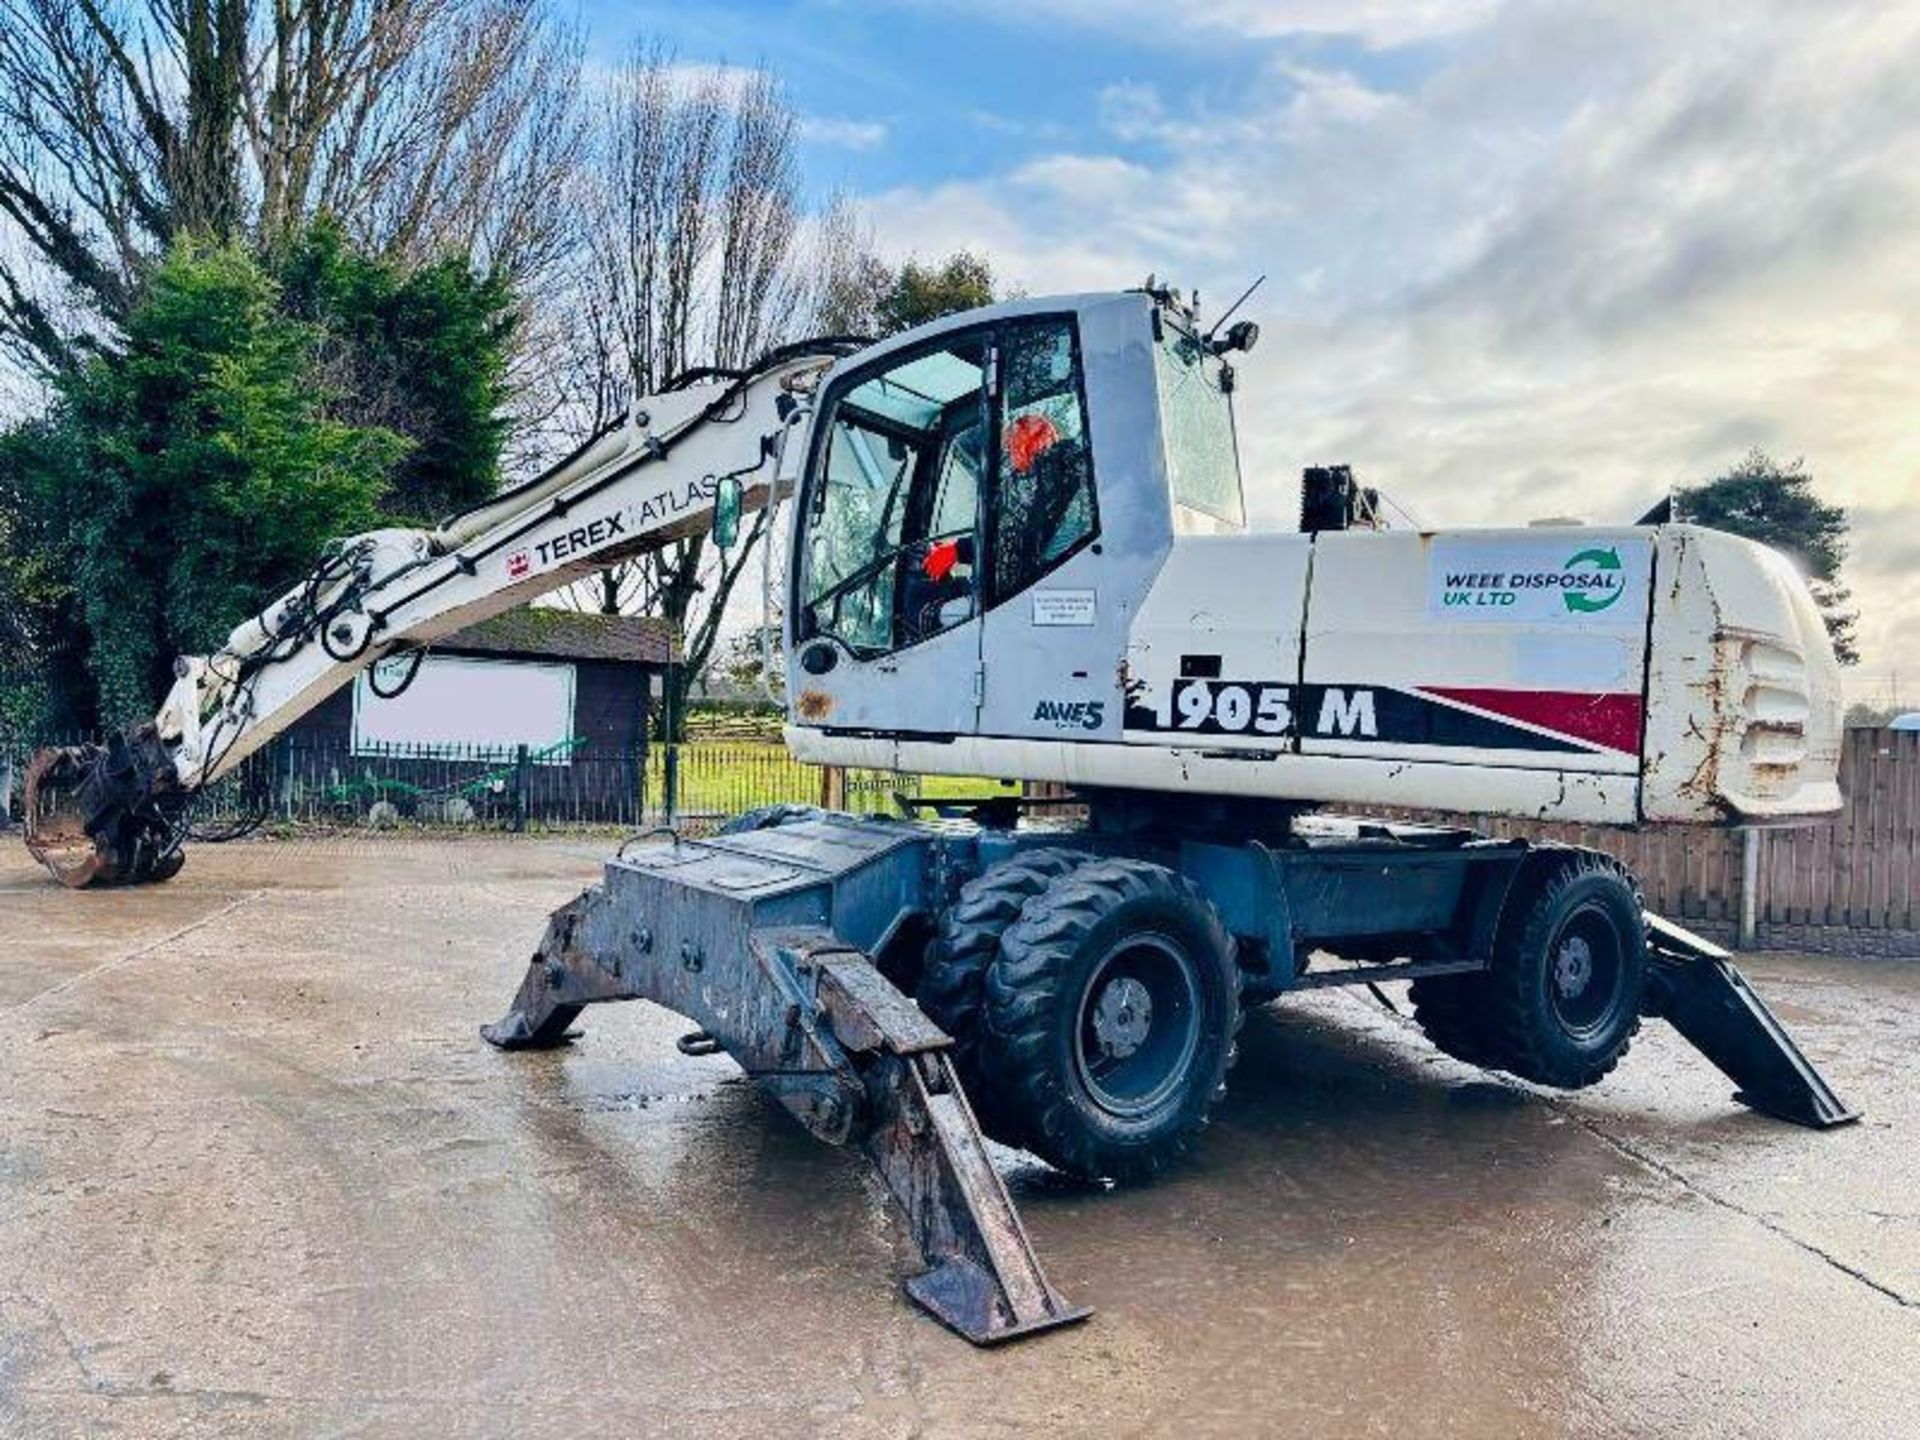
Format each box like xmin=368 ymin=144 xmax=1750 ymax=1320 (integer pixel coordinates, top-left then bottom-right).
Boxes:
xmin=914 ymin=851 xmax=1087 ymax=1144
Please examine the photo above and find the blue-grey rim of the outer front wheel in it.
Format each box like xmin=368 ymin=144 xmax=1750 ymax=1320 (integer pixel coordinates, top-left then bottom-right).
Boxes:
xmin=1073 ymin=935 xmax=1200 ymax=1119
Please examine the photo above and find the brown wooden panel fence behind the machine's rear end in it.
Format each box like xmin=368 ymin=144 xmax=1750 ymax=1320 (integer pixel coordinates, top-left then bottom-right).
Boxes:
xmin=1428 ymin=730 xmax=1920 ymax=954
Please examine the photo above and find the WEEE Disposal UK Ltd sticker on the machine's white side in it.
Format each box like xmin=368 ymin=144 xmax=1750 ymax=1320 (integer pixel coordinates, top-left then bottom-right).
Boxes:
xmin=1427 ymin=528 xmax=1653 ymax=630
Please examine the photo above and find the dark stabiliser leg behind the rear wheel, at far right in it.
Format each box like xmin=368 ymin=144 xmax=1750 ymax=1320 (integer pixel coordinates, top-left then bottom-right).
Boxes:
xmin=1645 ymin=914 xmax=1860 ymax=1129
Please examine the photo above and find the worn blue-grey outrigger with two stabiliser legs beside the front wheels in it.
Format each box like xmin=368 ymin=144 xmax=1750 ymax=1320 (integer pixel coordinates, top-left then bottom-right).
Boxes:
xmin=480 ymin=843 xmax=1091 ymax=1346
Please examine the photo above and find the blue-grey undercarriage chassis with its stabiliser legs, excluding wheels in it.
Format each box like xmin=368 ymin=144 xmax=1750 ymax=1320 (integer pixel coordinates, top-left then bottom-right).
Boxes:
xmin=482 ymin=816 xmax=1855 ymax=1344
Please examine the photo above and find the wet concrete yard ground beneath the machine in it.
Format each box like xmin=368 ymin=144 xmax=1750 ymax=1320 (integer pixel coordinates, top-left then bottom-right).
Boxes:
xmin=0 ymin=835 xmax=1920 ymax=1440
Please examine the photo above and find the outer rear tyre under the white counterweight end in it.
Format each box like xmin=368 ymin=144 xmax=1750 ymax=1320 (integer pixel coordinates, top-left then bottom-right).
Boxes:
xmin=1475 ymin=851 xmax=1647 ymax=1091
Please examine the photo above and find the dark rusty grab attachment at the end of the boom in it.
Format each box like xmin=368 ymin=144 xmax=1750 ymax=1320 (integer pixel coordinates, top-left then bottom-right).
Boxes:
xmin=23 ymin=726 xmax=184 ymax=889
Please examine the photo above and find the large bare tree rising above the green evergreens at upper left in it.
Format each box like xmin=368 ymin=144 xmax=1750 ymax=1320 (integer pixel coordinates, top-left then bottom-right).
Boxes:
xmin=0 ymin=0 xmax=580 ymax=372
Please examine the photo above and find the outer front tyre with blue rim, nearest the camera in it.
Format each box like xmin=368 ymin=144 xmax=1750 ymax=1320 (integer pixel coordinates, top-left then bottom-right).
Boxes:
xmin=985 ymin=860 xmax=1240 ymax=1181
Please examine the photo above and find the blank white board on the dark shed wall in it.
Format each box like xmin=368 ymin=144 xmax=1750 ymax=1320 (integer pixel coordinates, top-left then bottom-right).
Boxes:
xmin=353 ymin=655 xmax=574 ymax=764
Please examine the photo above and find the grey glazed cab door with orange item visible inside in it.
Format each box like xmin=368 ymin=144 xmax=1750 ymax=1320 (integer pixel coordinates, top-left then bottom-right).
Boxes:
xmin=787 ymin=328 xmax=995 ymax=739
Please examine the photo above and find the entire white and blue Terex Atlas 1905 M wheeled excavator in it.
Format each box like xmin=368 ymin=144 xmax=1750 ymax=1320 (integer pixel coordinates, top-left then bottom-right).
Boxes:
xmin=29 ymin=286 xmax=1851 ymax=1342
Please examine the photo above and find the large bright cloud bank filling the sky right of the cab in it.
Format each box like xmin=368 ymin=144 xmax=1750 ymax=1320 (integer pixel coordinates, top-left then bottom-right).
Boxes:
xmin=872 ymin=0 xmax=1920 ymax=698
